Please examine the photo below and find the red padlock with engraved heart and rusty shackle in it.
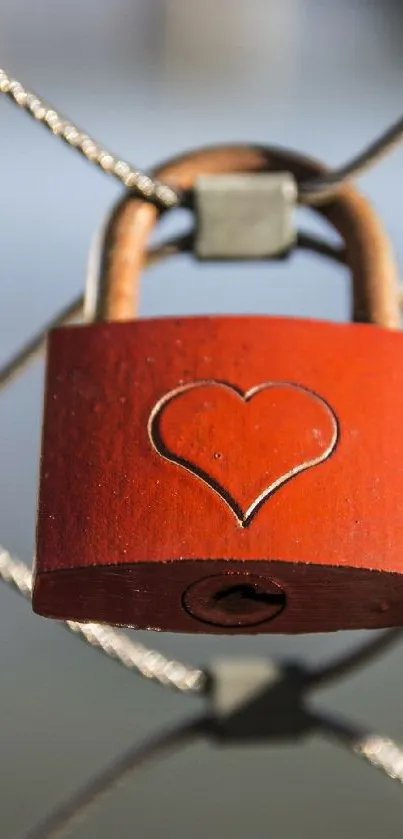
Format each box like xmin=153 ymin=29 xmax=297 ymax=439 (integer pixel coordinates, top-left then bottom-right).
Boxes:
xmin=33 ymin=147 xmax=403 ymax=634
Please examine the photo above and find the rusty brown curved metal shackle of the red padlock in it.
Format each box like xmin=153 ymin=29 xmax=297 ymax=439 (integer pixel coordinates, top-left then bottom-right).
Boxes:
xmin=95 ymin=145 xmax=400 ymax=329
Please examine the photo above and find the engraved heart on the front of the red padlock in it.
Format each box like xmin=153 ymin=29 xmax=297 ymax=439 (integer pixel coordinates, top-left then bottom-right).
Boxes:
xmin=148 ymin=379 xmax=339 ymax=527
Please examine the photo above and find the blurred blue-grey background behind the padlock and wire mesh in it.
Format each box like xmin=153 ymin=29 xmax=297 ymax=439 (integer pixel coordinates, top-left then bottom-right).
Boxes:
xmin=0 ymin=0 xmax=403 ymax=839
